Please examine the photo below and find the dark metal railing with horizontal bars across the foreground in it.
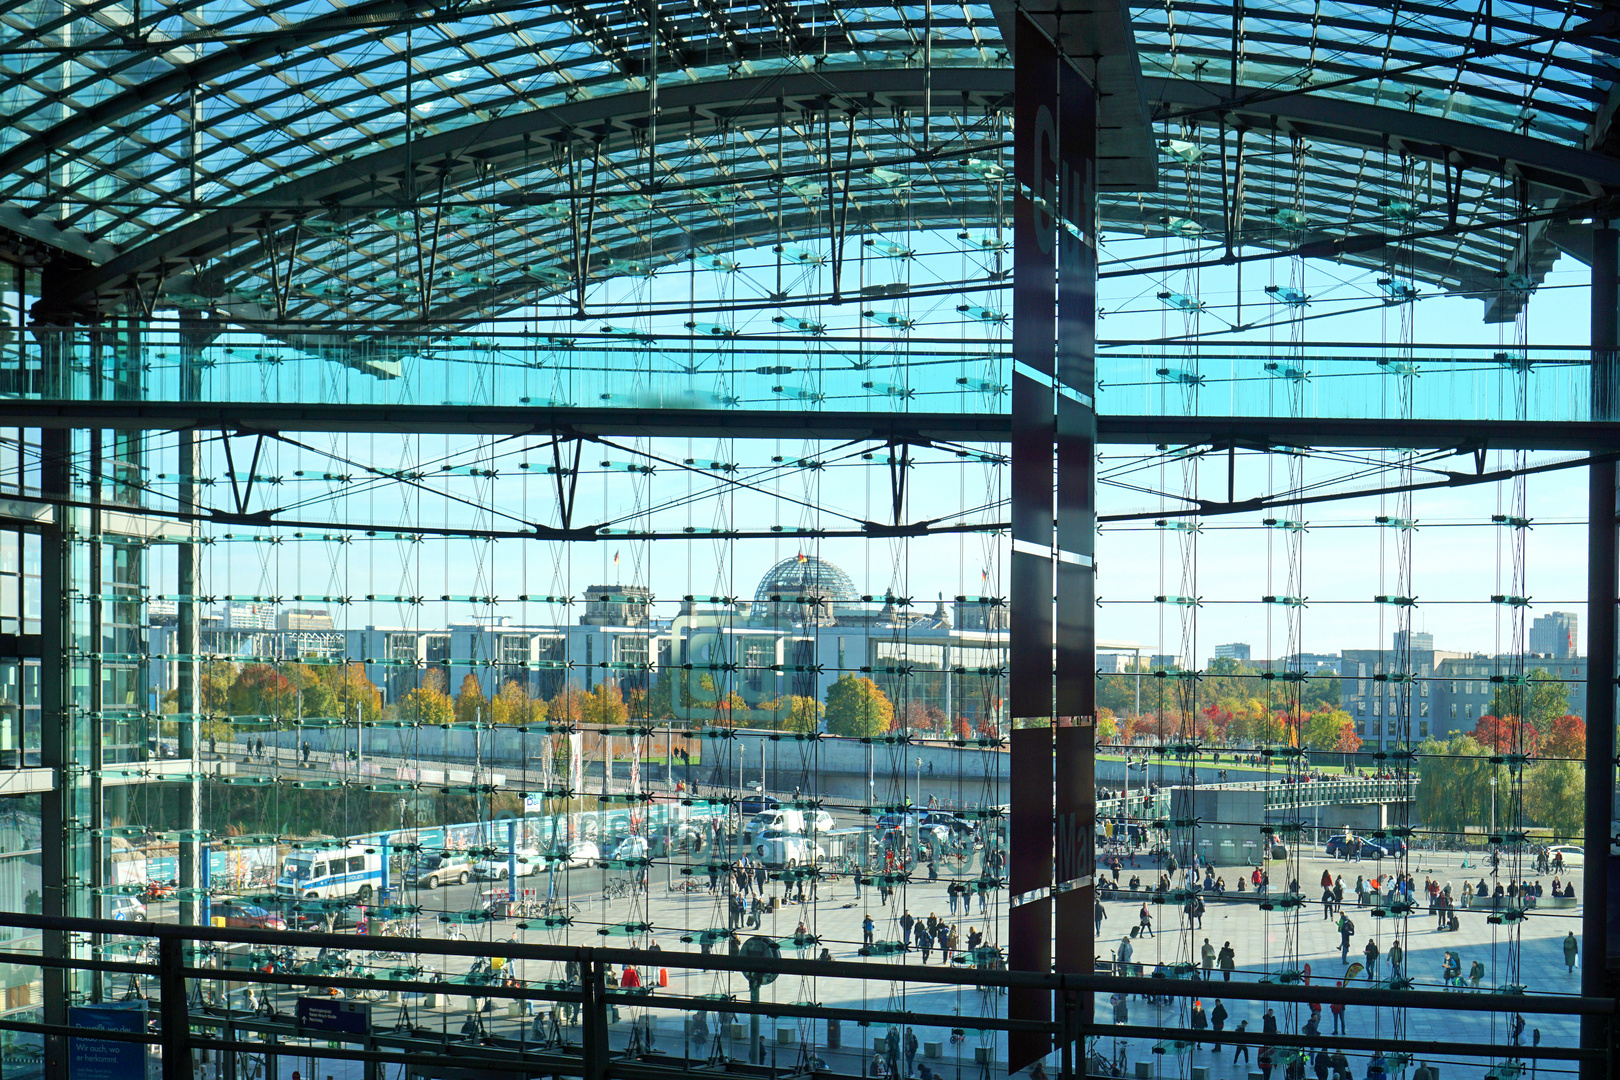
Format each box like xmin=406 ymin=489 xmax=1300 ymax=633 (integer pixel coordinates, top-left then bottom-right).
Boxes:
xmin=0 ymin=913 xmax=1615 ymax=1080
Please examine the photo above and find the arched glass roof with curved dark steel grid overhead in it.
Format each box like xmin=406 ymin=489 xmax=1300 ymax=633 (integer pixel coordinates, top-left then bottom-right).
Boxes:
xmin=0 ymin=0 xmax=1612 ymax=325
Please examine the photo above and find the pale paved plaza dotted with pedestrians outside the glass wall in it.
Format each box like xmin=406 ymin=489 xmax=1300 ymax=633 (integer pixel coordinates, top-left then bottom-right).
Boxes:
xmin=275 ymin=853 xmax=1584 ymax=1080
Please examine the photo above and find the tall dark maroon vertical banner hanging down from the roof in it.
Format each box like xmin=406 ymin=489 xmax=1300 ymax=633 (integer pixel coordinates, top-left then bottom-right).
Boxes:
xmin=1008 ymin=15 xmax=1097 ymax=1072
